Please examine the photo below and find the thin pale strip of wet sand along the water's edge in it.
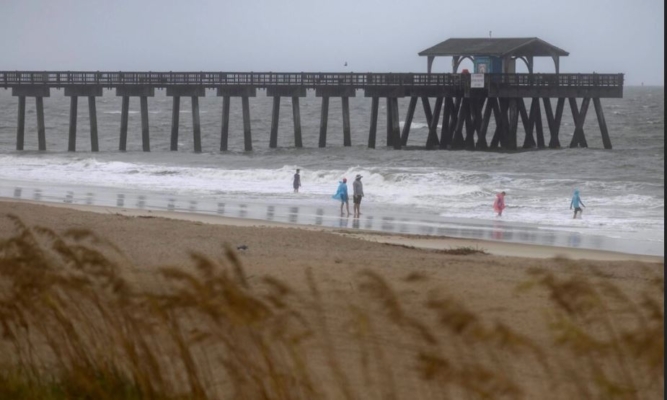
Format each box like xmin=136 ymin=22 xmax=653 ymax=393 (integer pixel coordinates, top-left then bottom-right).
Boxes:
xmin=0 ymin=197 xmax=664 ymax=263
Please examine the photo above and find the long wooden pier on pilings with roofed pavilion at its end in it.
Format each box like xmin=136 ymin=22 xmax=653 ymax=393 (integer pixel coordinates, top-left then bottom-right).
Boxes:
xmin=0 ymin=38 xmax=624 ymax=152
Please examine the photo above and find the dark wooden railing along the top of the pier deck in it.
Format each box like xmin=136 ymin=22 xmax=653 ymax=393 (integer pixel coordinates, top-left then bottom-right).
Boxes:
xmin=0 ymin=71 xmax=623 ymax=89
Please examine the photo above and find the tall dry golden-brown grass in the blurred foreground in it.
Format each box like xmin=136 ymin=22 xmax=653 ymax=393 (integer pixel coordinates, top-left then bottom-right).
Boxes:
xmin=0 ymin=217 xmax=664 ymax=400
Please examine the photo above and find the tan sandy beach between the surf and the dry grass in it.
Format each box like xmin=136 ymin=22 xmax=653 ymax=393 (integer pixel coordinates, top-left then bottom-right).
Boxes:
xmin=0 ymin=200 xmax=664 ymax=392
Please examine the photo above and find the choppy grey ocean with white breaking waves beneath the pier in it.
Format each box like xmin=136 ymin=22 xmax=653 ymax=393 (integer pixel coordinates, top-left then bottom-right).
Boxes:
xmin=0 ymin=87 xmax=665 ymax=255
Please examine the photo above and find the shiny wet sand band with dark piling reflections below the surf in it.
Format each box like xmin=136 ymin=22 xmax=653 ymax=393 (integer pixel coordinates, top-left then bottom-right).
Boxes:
xmin=0 ymin=187 xmax=661 ymax=254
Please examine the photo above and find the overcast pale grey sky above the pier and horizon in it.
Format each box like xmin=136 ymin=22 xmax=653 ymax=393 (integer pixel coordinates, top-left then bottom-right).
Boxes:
xmin=0 ymin=0 xmax=665 ymax=85
